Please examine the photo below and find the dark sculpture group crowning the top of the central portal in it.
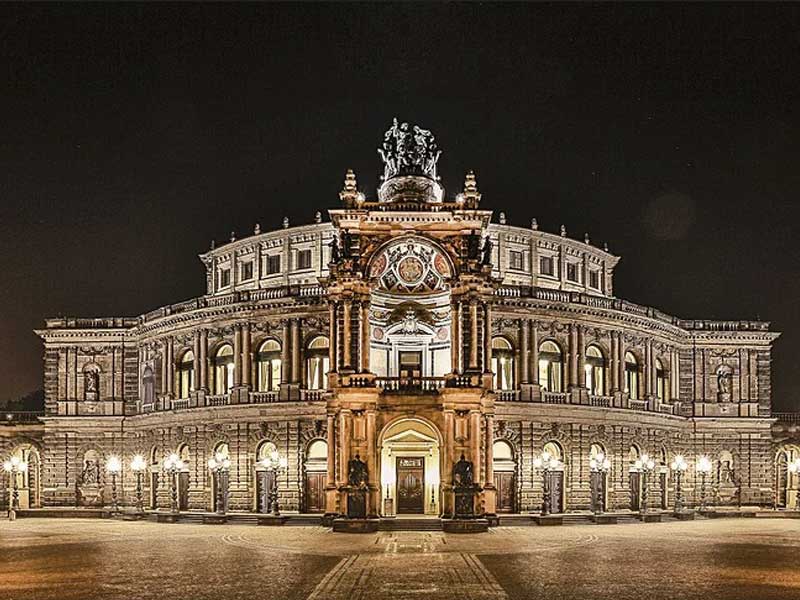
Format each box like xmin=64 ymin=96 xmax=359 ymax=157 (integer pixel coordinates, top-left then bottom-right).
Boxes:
xmin=378 ymin=118 xmax=441 ymax=181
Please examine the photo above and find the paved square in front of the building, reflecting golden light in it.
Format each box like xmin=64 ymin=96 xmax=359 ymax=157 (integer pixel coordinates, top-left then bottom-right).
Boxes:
xmin=0 ymin=519 xmax=800 ymax=600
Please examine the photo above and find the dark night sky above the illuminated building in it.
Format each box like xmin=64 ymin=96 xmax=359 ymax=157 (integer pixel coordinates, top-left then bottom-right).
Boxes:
xmin=0 ymin=4 xmax=800 ymax=409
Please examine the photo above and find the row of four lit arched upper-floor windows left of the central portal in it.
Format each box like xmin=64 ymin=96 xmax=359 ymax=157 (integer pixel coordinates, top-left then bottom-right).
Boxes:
xmin=175 ymin=336 xmax=330 ymax=398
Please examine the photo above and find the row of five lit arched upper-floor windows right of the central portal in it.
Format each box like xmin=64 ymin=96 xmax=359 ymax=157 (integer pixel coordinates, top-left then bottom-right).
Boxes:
xmin=492 ymin=337 xmax=668 ymax=402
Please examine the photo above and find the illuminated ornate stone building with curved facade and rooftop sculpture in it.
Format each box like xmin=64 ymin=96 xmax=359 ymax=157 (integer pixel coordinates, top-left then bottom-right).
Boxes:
xmin=0 ymin=124 xmax=797 ymax=516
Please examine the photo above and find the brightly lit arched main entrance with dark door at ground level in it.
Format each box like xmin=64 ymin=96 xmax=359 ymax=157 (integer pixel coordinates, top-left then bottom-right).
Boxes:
xmin=379 ymin=417 xmax=441 ymax=516
